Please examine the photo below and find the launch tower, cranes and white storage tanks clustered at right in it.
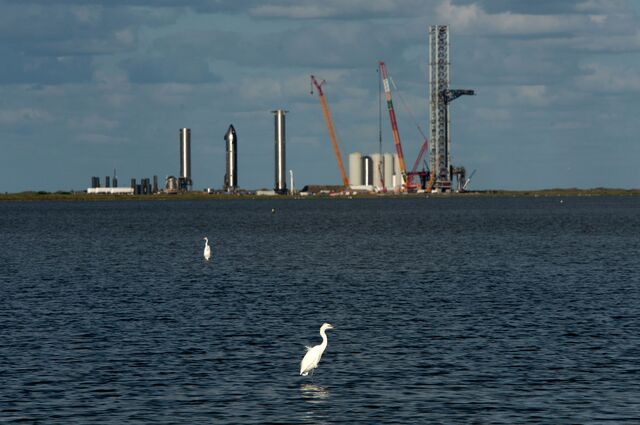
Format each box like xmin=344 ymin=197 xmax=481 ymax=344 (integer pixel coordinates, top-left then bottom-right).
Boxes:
xmin=311 ymin=25 xmax=475 ymax=194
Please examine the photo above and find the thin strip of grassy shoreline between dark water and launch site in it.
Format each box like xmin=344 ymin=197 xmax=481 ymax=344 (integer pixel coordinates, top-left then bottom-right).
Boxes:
xmin=0 ymin=188 xmax=640 ymax=202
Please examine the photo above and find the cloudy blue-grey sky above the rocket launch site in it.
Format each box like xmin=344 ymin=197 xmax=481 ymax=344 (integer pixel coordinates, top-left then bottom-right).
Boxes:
xmin=0 ymin=0 xmax=640 ymax=192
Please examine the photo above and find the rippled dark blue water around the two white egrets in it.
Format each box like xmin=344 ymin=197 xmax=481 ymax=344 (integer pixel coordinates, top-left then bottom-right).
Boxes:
xmin=0 ymin=198 xmax=640 ymax=424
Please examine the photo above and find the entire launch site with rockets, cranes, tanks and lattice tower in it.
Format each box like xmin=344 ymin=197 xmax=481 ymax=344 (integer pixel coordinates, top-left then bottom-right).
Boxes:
xmin=87 ymin=25 xmax=475 ymax=196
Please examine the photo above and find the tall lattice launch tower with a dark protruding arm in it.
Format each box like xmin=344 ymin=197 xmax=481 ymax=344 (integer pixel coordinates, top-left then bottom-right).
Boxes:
xmin=428 ymin=25 xmax=475 ymax=192
